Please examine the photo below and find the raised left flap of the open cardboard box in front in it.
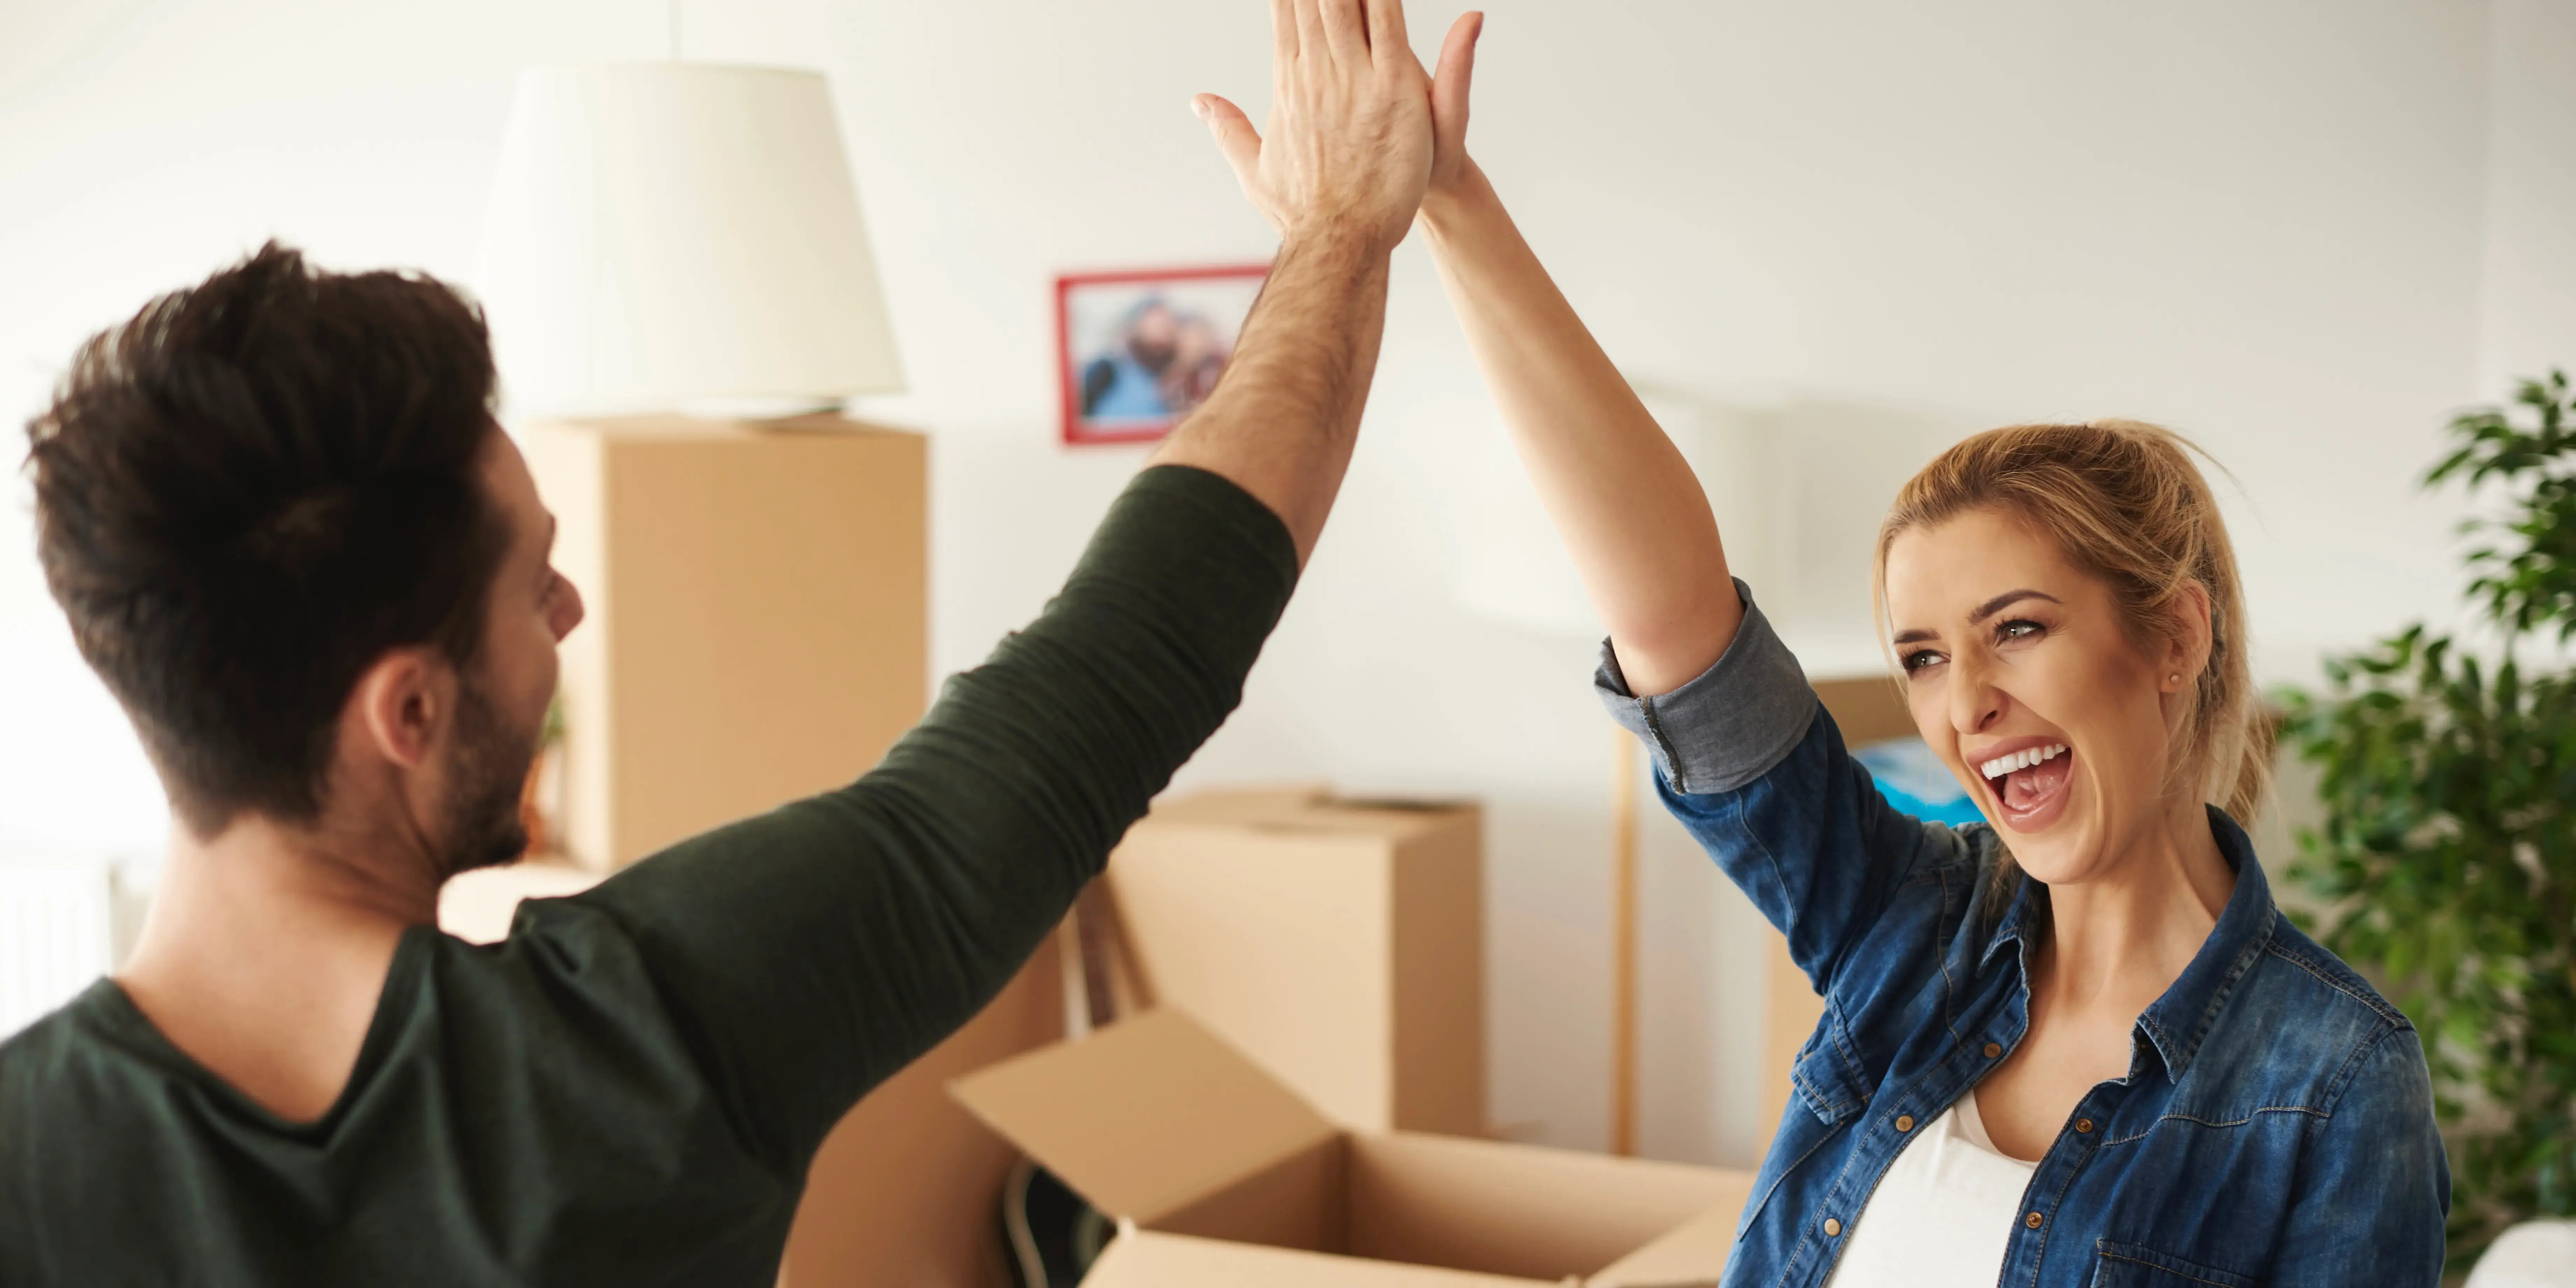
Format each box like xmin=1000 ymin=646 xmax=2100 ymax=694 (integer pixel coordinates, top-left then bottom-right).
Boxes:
xmin=948 ymin=1010 xmax=1339 ymax=1224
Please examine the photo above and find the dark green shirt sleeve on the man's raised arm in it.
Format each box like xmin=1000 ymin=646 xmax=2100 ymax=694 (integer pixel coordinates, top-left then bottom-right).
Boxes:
xmin=556 ymin=466 xmax=1296 ymax=1175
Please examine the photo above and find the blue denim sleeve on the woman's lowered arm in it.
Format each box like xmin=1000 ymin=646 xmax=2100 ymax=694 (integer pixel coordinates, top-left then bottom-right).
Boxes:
xmin=2267 ymin=1025 xmax=2450 ymax=1288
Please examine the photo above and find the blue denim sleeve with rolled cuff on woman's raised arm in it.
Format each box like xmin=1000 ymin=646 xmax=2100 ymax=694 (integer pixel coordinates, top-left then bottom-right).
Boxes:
xmin=1592 ymin=580 xmax=1973 ymax=992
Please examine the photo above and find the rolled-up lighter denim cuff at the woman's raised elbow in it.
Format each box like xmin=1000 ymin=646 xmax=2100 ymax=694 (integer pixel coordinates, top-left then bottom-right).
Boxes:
xmin=1592 ymin=577 xmax=1816 ymax=796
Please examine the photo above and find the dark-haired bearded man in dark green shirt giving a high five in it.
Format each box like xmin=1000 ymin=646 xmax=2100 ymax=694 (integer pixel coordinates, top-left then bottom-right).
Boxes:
xmin=0 ymin=0 xmax=1432 ymax=1288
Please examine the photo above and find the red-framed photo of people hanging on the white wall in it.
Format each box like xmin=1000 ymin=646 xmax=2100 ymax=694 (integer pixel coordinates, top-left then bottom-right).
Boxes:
xmin=1056 ymin=263 xmax=1270 ymax=443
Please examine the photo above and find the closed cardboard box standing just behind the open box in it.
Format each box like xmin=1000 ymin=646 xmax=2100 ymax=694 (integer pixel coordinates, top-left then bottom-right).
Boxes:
xmin=1110 ymin=786 xmax=1486 ymax=1136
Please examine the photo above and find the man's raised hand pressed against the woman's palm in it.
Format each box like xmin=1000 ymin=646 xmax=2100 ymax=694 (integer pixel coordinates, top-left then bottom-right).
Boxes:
xmin=1193 ymin=0 xmax=1463 ymax=252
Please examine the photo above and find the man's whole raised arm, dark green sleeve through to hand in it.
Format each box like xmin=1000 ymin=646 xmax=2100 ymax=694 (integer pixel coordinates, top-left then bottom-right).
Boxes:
xmin=564 ymin=0 xmax=1432 ymax=1177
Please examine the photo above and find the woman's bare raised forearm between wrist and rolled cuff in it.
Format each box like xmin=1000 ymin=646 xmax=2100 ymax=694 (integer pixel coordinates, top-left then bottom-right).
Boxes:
xmin=1422 ymin=162 xmax=1744 ymax=695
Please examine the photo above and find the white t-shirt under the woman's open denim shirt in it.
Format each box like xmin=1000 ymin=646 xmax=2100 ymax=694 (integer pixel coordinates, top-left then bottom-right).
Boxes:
xmin=1824 ymin=1092 xmax=2040 ymax=1288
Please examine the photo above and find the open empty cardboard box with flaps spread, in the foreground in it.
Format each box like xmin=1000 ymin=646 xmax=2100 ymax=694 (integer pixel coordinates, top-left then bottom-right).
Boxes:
xmin=951 ymin=1010 xmax=1752 ymax=1288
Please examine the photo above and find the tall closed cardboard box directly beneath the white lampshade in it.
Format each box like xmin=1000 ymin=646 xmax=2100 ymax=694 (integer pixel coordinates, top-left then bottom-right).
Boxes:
xmin=518 ymin=417 xmax=930 ymax=868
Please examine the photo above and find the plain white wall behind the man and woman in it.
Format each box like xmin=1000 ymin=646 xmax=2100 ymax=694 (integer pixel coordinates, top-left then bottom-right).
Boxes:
xmin=0 ymin=0 xmax=2576 ymax=1159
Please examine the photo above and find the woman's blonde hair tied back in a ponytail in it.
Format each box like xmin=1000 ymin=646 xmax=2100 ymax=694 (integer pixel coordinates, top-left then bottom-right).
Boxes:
xmin=1873 ymin=420 xmax=2272 ymax=827
